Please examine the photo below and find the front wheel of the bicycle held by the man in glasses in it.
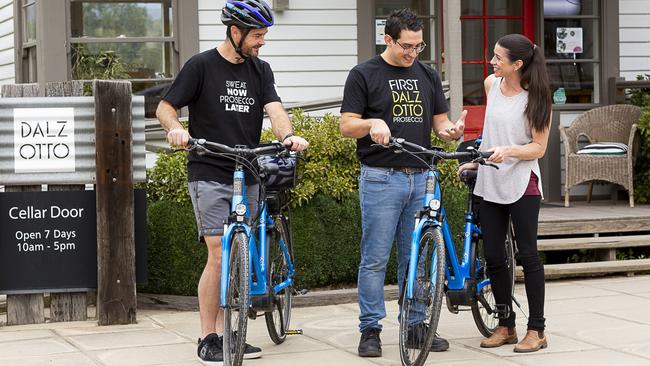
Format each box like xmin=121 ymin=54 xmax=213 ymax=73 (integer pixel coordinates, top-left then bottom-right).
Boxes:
xmin=399 ymin=228 xmax=445 ymax=366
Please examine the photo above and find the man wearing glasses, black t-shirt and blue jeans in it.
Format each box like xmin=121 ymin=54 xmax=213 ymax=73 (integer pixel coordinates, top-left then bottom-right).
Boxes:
xmin=340 ymin=9 xmax=467 ymax=357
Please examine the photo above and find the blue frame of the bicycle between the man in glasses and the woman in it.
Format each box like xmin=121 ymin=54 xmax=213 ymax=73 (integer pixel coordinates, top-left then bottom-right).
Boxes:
xmin=405 ymin=164 xmax=490 ymax=299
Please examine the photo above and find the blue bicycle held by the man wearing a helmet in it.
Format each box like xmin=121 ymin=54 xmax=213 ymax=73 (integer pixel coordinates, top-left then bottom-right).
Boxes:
xmin=186 ymin=139 xmax=297 ymax=366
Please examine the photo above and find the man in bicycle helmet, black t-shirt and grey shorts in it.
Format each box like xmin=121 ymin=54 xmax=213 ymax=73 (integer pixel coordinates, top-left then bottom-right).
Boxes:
xmin=156 ymin=0 xmax=308 ymax=365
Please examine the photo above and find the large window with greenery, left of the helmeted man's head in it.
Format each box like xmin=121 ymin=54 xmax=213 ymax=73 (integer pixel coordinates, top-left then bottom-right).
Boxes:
xmin=69 ymin=0 xmax=178 ymax=117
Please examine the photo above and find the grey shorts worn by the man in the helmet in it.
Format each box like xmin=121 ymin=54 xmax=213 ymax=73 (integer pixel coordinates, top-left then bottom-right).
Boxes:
xmin=188 ymin=181 xmax=259 ymax=241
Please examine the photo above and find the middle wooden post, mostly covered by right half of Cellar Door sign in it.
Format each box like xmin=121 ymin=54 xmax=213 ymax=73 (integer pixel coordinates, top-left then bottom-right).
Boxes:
xmin=45 ymin=81 xmax=88 ymax=322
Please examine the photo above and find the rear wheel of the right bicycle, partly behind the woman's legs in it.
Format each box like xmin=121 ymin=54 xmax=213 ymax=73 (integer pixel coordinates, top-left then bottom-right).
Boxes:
xmin=470 ymin=221 xmax=516 ymax=337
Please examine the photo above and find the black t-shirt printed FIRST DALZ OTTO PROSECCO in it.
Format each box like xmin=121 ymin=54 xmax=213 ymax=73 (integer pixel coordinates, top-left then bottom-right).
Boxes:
xmin=341 ymin=56 xmax=449 ymax=167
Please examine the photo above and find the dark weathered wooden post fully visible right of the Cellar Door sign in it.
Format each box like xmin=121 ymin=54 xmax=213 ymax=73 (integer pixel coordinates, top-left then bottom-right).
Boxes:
xmin=93 ymin=80 xmax=136 ymax=325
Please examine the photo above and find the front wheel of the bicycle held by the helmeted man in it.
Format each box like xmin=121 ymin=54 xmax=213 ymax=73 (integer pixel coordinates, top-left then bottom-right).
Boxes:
xmin=223 ymin=232 xmax=250 ymax=366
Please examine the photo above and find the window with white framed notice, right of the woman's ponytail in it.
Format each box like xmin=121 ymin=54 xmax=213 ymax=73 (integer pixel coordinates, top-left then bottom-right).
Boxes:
xmin=543 ymin=0 xmax=600 ymax=103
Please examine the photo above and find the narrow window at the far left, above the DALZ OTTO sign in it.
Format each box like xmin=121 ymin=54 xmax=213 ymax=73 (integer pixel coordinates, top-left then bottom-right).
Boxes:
xmin=20 ymin=0 xmax=37 ymax=83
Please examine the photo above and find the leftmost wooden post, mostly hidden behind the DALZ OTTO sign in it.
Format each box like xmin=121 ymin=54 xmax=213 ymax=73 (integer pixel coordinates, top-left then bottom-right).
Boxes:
xmin=1 ymin=84 xmax=45 ymax=325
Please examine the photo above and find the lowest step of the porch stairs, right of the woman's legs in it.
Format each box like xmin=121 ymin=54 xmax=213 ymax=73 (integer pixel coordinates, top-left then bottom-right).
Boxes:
xmin=516 ymin=259 xmax=650 ymax=280
